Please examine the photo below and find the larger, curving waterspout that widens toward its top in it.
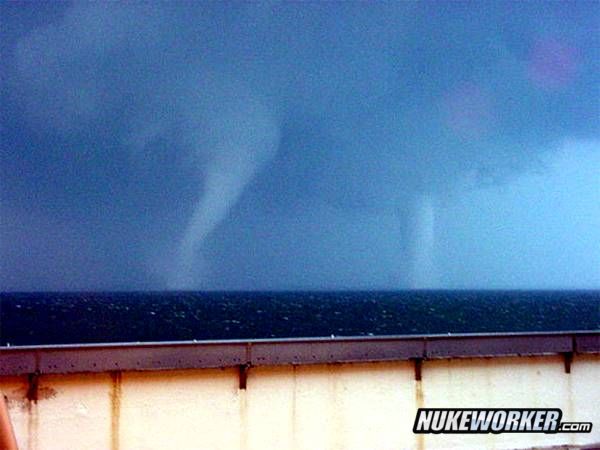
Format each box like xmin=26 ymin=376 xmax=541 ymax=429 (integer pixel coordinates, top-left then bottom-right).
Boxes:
xmin=168 ymin=92 xmax=280 ymax=289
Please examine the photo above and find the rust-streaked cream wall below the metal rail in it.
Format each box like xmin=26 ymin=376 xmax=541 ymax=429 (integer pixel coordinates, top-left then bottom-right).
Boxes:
xmin=0 ymin=355 xmax=600 ymax=450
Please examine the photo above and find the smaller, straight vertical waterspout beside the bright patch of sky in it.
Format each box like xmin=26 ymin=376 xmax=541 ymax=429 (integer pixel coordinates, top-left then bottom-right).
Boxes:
xmin=408 ymin=194 xmax=436 ymax=289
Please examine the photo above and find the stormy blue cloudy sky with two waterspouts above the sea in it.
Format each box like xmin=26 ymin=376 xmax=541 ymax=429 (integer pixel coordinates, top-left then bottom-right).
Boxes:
xmin=0 ymin=1 xmax=600 ymax=291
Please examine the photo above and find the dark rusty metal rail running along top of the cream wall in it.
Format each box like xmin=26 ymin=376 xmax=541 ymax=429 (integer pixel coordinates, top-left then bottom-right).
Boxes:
xmin=0 ymin=331 xmax=600 ymax=376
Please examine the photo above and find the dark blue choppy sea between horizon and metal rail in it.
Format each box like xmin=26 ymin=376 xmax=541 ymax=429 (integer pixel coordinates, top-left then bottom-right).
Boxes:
xmin=0 ymin=291 xmax=600 ymax=346
